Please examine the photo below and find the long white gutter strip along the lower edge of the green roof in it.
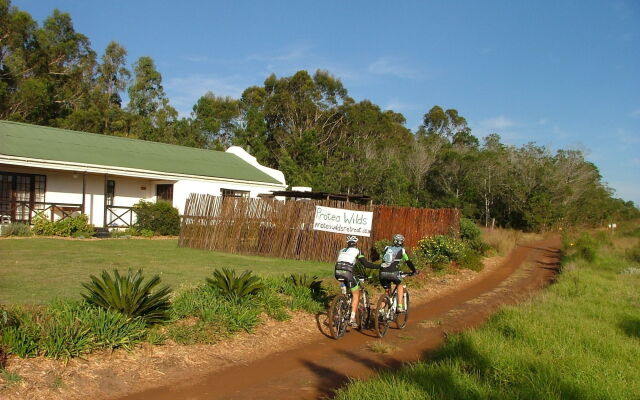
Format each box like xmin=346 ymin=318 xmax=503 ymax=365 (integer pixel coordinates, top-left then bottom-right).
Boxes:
xmin=0 ymin=154 xmax=287 ymax=189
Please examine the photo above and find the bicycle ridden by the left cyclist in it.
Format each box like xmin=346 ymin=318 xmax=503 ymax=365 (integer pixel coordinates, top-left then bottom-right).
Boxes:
xmin=328 ymin=277 xmax=371 ymax=340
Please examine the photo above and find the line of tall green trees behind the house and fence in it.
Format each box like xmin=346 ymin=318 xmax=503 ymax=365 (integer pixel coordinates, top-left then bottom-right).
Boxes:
xmin=0 ymin=0 xmax=640 ymax=230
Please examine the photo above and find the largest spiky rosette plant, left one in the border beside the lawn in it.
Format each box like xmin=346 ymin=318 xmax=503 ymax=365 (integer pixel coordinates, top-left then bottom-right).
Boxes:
xmin=82 ymin=269 xmax=171 ymax=325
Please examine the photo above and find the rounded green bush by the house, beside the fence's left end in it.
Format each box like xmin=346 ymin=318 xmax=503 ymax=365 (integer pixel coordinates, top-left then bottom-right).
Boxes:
xmin=134 ymin=200 xmax=180 ymax=235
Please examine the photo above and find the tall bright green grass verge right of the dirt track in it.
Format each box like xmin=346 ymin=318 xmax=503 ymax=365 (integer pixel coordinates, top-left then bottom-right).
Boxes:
xmin=337 ymin=231 xmax=640 ymax=400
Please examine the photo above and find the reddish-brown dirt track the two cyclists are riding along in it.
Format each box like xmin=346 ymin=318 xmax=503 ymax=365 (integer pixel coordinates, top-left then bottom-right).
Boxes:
xmin=123 ymin=237 xmax=560 ymax=400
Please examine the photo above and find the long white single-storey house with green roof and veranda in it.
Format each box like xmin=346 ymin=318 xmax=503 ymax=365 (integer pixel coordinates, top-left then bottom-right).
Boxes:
xmin=0 ymin=121 xmax=287 ymax=227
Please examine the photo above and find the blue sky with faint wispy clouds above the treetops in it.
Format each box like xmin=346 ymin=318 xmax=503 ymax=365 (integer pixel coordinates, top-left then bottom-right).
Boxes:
xmin=12 ymin=0 xmax=640 ymax=205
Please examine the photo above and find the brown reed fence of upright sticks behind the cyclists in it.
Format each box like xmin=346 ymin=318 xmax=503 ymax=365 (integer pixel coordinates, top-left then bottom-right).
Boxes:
xmin=179 ymin=194 xmax=460 ymax=262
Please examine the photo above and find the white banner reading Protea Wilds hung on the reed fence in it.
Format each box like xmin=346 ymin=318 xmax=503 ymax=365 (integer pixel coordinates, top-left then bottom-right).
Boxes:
xmin=313 ymin=206 xmax=373 ymax=237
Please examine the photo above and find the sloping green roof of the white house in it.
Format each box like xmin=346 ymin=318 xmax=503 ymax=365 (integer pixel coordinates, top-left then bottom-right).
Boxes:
xmin=0 ymin=121 xmax=280 ymax=184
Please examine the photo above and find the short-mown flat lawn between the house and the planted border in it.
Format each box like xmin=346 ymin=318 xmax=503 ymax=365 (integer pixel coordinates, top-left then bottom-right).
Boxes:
xmin=0 ymin=238 xmax=333 ymax=303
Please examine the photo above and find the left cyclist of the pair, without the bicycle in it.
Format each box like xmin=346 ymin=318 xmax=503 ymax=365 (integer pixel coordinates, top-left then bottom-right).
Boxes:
xmin=335 ymin=235 xmax=379 ymax=327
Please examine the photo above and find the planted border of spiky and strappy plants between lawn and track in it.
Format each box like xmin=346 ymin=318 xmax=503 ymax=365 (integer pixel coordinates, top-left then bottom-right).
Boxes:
xmin=0 ymin=269 xmax=327 ymax=360
